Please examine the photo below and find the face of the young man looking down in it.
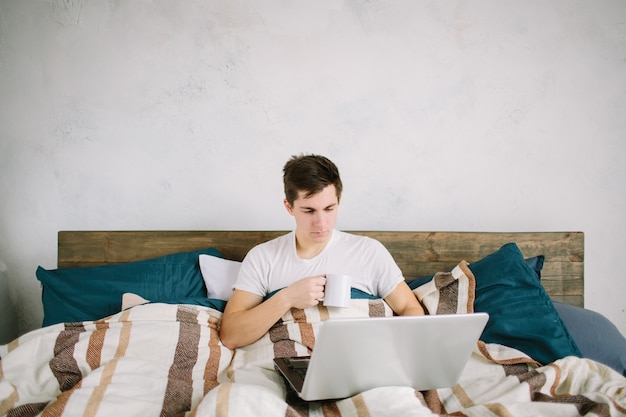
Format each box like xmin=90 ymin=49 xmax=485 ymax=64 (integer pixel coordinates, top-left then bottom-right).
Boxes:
xmin=285 ymin=185 xmax=339 ymax=244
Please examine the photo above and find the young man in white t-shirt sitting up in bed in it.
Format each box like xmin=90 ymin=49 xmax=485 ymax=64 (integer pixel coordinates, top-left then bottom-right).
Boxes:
xmin=220 ymin=155 xmax=424 ymax=349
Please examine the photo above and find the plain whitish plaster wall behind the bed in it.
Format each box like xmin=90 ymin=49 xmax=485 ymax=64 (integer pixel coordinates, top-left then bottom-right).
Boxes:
xmin=0 ymin=0 xmax=626 ymax=334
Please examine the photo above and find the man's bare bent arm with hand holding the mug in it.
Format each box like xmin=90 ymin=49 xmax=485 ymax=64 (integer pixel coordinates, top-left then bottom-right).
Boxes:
xmin=220 ymin=276 xmax=326 ymax=349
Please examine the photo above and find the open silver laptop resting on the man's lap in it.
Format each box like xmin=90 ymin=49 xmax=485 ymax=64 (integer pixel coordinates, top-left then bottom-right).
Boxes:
xmin=274 ymin=313 xmax=489 ymax=401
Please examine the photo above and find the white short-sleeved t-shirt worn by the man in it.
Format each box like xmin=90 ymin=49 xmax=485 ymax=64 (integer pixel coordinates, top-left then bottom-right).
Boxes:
xmin=235 ymin=230 xmax=404 ymax=298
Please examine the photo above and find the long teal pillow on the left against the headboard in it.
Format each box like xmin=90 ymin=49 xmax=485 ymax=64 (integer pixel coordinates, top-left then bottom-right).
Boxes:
xmin=36 ymin=248 xmax=220 ymax=326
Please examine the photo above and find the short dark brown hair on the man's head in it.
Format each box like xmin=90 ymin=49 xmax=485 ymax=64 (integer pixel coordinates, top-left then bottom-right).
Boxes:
xmin=283 ymin=154 xmax=343 ymax=206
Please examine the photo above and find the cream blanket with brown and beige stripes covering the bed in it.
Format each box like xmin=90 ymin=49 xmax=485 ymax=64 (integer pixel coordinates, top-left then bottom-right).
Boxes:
xmin=0 ymin=299 xmax=626 ymax=417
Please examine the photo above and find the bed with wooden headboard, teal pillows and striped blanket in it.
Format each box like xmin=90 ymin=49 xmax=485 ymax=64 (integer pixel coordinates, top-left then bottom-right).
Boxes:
xmin=0 ymin=231 xmax=626 ymax=416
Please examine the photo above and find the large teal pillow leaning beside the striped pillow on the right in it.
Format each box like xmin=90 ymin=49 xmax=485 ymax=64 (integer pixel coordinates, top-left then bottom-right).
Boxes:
xmin=469 ymin=243 xmax=582 ymax=364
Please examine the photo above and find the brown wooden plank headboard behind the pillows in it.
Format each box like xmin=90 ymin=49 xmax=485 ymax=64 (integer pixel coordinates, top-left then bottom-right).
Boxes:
xmin=58 ymin=230 xmax=584 ymax=307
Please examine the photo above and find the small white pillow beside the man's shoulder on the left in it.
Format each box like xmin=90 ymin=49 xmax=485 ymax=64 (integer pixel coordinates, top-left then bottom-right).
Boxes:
xmin=199 ymin=255 xmax=241 ymax=300
